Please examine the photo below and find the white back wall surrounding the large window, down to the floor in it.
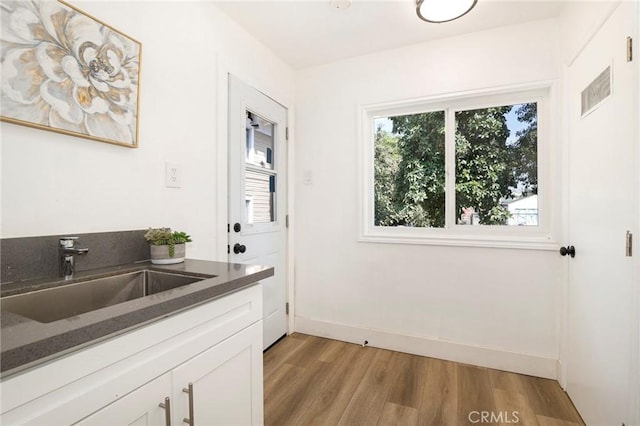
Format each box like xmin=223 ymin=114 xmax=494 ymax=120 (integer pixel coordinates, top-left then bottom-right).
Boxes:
xmin=295 ymin=20 xmax=561 ymax=377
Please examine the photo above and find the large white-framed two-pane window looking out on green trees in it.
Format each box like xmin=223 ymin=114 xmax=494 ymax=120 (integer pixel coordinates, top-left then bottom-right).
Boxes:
xmin=361 ymin=87 xmax=553 ymax=248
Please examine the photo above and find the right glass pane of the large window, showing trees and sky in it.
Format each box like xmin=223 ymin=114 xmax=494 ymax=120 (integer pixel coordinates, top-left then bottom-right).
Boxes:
xmin=455 ymin=103 xmax=538 ymax=226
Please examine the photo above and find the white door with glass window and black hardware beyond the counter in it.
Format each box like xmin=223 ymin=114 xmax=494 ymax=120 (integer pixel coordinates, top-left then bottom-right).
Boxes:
xmin=228 ymin=75 xmax=287 ymax=349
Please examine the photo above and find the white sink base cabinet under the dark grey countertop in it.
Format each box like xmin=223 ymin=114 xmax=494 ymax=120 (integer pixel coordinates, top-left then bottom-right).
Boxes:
xmin=0 ymin=285 xmax=263 ymax=426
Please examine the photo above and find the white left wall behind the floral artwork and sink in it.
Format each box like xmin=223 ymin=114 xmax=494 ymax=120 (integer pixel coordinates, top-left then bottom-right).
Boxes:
xmin=0 ymin=0 xmax=294 ymax=259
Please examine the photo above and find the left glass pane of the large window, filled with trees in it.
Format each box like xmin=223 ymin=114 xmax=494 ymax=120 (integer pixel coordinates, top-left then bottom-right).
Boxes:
xmin=374 ymin=111 xmax=445 ymax=228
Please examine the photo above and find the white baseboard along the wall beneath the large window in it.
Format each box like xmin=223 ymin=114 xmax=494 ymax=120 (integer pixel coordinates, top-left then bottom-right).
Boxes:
xmin=294 ymin=317 xmax=560 ymax=380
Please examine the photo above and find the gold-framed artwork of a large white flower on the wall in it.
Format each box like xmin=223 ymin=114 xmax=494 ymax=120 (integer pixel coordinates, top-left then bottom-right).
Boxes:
xmin=0 ymin=0 xmax=142 ymax=148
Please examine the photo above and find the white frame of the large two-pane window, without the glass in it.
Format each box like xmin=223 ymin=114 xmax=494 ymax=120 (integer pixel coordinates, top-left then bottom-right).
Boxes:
xmin=358 ymin=82 xmax=562 ymax=250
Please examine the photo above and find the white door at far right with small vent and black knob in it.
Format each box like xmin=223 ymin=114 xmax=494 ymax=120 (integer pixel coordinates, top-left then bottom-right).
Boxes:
xmin=565 ymin=2 xmax=638 ymax=426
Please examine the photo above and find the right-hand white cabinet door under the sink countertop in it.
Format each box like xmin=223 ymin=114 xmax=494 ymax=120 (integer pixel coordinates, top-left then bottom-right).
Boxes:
xmin=172 ymin=321 xmax=263 ymax=426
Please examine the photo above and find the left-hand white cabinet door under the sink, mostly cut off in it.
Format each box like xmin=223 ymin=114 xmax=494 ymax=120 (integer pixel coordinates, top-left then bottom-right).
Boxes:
xmin=76 ymin=373 xmax=171 ymax=426
